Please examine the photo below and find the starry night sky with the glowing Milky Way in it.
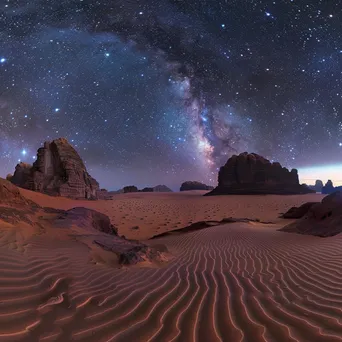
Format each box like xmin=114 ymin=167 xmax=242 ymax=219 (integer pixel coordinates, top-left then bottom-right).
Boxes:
xmin=0 ymin=0 xmax=342 ymax=189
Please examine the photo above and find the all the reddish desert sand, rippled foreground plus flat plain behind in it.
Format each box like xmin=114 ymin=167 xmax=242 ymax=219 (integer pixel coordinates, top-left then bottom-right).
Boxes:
xmin=0 ymin=190 xmax=342 ymax=342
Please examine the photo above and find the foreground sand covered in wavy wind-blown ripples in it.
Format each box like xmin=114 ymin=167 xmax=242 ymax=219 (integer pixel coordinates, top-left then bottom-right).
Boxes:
xmin=0 ymin=224 xmax=342 ymax=342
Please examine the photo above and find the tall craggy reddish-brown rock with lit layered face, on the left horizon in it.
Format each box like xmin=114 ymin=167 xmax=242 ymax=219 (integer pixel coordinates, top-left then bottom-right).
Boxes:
xmin=11 ymin=138 xmax=99 ymax=199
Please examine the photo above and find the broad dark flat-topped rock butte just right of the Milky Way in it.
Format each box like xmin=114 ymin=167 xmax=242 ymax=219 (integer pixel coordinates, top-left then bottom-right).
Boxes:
xmin=206 ymin=152 xmax=313 ymax=195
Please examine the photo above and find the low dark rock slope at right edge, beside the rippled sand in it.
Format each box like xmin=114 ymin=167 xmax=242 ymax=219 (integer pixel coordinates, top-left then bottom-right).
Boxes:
xmin=280 ymin=191 xmax=342 ymax=237
